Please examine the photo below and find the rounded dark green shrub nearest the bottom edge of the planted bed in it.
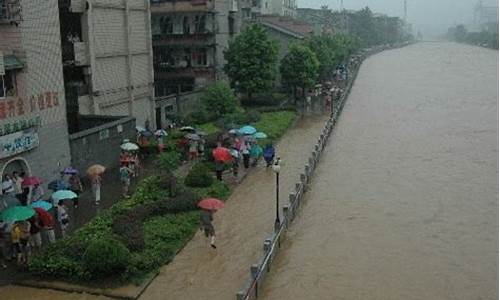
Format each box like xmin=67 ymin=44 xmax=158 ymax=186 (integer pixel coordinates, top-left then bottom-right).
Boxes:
xmin=83 ymin=237 xmax=130 ymax=278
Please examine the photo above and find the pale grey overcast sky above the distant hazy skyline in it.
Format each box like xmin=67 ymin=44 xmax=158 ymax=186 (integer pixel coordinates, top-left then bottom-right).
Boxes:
xmin=298 ymin=0 xmax=488 ymax=35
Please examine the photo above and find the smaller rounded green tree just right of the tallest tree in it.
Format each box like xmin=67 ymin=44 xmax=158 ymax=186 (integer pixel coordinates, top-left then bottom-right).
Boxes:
xmin=280 ymin=43 xmax=319 ymax=101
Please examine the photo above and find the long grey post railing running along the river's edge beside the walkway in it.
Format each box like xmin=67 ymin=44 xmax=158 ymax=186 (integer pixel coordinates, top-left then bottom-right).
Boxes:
xmin=236 ymin=44 xmax=407 ymax=300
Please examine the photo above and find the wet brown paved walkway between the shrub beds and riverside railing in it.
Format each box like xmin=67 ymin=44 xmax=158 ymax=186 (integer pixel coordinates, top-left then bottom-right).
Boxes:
xmin=0 ymin=116 xmax=326 ymax=300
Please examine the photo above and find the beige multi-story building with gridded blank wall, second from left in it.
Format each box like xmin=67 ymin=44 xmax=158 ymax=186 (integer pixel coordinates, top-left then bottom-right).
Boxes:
xmin=59 ymin=0 xmax=155 ymax=133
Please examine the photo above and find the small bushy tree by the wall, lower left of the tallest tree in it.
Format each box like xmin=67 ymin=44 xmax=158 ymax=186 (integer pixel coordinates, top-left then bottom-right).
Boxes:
xmin=201 ymin=81 xmax=238 ymax=117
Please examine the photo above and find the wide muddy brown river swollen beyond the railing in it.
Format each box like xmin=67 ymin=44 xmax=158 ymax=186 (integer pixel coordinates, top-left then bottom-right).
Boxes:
xmin=260 ymin=43 xmax=498 ymax=300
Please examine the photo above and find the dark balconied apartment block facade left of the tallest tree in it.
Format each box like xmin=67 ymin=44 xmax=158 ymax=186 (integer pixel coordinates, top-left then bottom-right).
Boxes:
xmin=151 ymin=0 xmax=241 ymax=125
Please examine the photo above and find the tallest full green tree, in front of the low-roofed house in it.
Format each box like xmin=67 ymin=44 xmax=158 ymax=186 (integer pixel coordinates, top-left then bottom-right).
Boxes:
xmin=224 ymin=24 xmax=279 ymax=99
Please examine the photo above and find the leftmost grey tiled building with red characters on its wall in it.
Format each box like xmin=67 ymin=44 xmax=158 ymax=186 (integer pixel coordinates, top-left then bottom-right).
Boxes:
xmin=0 ymin=0 xmax=70 ymax=183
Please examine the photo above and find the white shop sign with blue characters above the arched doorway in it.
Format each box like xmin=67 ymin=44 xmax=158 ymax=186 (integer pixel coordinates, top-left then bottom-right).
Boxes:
xmin=0 ymin=128 xmax=40 ymax=159
